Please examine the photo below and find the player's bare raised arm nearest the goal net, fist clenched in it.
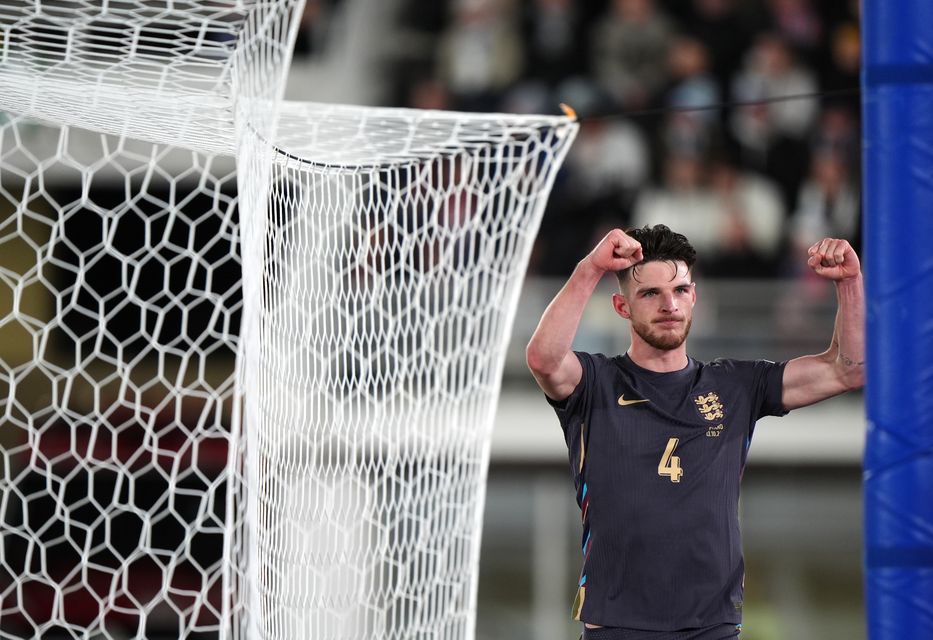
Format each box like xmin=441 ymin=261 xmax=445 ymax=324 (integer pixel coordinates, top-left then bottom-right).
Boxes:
xmin=525 ymin=229 xmax=642 ymax=400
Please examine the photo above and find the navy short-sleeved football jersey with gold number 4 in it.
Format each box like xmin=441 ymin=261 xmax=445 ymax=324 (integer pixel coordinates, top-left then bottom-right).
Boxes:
xmin=551 ymin=353 xmax=786 ymax=631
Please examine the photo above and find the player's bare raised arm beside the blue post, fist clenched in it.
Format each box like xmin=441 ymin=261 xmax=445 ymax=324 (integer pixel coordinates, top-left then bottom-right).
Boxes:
xmin=782 ymin=238 xmax=865 ymax=411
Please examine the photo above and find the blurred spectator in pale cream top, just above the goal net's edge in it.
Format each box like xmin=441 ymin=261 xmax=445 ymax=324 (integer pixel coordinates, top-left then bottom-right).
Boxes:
xmin=438 ymin=0 xmax=523 ymax=111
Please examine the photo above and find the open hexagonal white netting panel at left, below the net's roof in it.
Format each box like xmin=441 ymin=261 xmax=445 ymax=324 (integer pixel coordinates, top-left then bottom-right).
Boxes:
xmin=0 ymin=117 xmax=242 ymax=638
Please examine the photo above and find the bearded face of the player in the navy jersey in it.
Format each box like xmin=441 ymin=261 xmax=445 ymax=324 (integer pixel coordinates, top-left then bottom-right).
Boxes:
xmin=616 ymin=261 xmax=696 ymax=351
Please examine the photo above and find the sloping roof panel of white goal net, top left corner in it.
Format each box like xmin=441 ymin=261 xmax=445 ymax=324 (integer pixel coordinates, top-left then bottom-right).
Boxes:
xmin=0 ymin=0 xmax=303 ymax=153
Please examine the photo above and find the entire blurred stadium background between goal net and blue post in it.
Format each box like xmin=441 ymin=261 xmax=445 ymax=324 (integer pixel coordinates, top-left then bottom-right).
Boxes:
xmin=287 ymin=0 xmax=865 ymax=640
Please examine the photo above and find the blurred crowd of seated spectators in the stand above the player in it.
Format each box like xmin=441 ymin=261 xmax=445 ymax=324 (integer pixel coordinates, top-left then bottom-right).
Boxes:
xmin=298 ymin=0 xmax=860 ymax=277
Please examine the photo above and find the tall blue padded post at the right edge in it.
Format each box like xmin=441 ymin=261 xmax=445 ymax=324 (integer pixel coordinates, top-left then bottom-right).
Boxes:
xmin=862 ymin=0 xmax=933 ymax=640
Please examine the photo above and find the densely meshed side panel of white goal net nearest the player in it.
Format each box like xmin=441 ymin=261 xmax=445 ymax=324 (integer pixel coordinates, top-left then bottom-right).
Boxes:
xmin=238 ymin=105 xmax=573 ymax=639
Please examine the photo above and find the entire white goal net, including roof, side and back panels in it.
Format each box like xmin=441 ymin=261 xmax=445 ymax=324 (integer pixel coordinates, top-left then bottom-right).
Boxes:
xmin=0 ymin=0 xmax=576 ymax=639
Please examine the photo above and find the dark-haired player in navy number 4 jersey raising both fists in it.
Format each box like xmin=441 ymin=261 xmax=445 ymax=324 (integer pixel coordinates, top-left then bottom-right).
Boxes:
xmin=526 ymin=225 xmax=864 ymax=640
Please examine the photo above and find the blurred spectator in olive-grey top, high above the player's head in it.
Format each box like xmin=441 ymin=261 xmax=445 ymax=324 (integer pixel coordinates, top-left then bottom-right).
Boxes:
xmin=590 ymin=0 xmax=674 ymax=108
